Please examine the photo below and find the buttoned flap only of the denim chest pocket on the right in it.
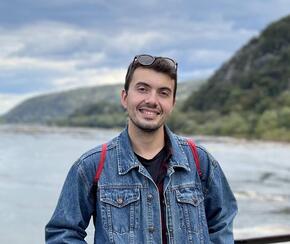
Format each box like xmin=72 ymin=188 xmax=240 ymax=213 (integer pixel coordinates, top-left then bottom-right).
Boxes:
xmin=176 ymin=187 xmax=204 ymax=206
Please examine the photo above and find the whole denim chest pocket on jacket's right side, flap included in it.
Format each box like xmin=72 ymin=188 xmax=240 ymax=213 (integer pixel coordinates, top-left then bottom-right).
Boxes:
xmin=175 ymin=186 xmax=207 ymax=236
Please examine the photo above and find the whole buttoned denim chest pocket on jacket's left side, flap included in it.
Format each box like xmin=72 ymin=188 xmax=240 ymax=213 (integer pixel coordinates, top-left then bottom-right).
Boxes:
xmin=100 ymin=187 xmax=140 ymax=233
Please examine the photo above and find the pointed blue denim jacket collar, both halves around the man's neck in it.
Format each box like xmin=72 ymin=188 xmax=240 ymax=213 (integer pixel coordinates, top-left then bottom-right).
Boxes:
xmin=117 ymin=126 xmax=190 ymax=175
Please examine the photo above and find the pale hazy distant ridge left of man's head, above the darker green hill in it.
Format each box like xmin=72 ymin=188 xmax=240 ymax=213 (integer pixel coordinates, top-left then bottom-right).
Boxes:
xmin=3 ymin=85 xmax=122 ymax=123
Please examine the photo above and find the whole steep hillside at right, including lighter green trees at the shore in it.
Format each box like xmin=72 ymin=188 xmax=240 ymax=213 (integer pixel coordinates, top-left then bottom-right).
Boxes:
xmin=182 ymin=16 xmax=290 ymax=141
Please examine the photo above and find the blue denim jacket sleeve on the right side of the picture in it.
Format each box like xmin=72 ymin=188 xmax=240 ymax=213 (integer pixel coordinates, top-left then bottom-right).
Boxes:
xmin=201 ymin=148 xmax=238 ymax=244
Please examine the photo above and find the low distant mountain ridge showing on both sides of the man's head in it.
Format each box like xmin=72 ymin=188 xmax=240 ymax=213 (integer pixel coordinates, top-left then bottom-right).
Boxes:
xmin=2 ymin=81 xmax=203 ymax=127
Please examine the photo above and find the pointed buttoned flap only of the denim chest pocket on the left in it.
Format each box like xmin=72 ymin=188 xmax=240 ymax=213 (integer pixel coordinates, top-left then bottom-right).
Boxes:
xmin=100 ymin=188 xmax=140 ymax=208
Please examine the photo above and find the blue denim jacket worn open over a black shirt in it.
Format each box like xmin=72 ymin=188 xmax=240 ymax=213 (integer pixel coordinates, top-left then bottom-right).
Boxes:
xmin=45 ymin=128 xmax=237 ymax=244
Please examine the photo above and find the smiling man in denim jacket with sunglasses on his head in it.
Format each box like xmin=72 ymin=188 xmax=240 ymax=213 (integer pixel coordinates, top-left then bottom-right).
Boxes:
xmin=46 ymin=55 xmax=237 ymax=244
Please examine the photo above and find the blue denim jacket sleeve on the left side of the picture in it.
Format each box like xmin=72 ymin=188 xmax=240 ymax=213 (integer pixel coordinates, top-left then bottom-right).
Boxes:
xmin=45 ymin=161 xmax=93 ymax=244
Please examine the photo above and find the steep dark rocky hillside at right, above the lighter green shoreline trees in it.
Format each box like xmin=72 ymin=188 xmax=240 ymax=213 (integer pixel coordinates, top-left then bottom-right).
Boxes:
xmin=184 ymin=16 xmax=290 ymax=113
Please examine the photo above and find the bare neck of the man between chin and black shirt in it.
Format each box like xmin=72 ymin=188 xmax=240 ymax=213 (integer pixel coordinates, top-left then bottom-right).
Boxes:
xmin=128 ymin=123 xmax=165 ymax=159
